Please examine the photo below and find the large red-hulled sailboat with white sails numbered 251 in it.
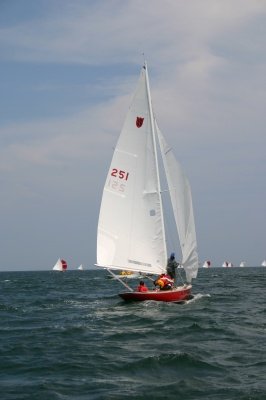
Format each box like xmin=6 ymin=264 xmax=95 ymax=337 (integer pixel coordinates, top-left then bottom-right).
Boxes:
xmin=96 ymin=62 xmax=199 ymax=302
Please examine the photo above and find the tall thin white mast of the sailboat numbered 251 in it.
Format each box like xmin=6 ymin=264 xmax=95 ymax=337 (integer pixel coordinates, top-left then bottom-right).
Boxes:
xmin=143 ymin=61 xmax=167 ymax=267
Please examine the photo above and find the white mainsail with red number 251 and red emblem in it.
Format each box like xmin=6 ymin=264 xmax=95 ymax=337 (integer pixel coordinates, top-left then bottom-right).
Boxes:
xmin=97 ymin=68 xmax=167 ymax=274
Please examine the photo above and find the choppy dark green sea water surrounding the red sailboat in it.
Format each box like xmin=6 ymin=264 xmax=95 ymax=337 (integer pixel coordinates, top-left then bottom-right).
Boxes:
xmin=0 ymin=267 xmax=266 ymax=400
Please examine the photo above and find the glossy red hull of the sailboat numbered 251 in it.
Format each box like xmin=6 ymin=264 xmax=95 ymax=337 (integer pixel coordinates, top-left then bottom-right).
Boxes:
xmin=119 ymin=285 xmax=192 ymax=302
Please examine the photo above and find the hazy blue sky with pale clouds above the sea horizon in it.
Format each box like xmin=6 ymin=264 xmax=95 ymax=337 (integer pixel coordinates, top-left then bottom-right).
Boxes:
xmin=0 ymin=0 xmax=266 ymax=271
